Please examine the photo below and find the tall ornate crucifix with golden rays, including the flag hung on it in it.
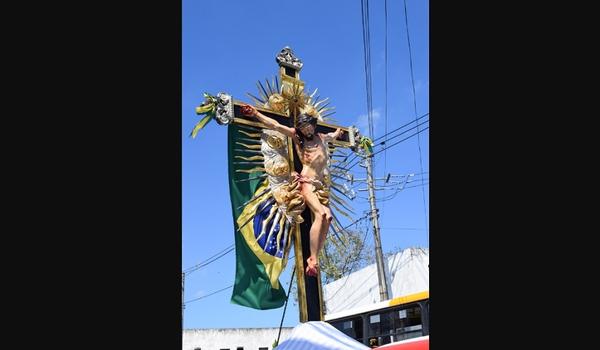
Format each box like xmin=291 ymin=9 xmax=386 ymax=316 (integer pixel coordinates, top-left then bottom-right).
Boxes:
xmin=192 ymin=47 xmax=361 ymax=322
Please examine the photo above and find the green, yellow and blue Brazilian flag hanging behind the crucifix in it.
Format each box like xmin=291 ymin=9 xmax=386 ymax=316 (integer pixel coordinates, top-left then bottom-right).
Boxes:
xmin=228 ymin=124 xmax=291 ymax=310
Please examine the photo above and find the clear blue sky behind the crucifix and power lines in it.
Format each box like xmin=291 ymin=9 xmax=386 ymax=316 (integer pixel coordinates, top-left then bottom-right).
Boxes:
xmin=181 ymin=0 xmax=429 ymax=328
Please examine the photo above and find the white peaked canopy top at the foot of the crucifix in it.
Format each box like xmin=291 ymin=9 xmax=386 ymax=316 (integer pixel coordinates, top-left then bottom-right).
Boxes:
xmin=275 ymin=321 xmax=370 ymax=350
